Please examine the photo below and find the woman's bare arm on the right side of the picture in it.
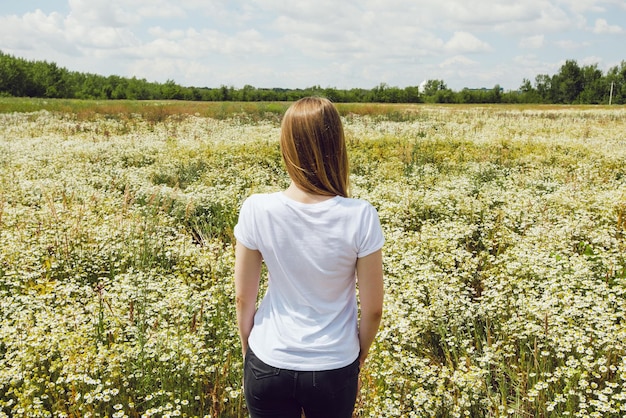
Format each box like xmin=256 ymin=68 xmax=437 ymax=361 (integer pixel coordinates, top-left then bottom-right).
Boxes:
xmin=356 ymin=250 xmax=384 ymax=366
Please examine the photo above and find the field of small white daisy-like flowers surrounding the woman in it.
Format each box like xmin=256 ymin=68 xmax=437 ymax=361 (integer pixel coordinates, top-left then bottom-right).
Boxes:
xmin=0 ymin=105 xmax=626 ymax=418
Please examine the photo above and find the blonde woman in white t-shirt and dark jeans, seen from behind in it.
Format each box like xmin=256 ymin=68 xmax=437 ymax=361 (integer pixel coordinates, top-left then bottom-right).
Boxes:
xmin=235 ymin=97 xmax=384 ymax=418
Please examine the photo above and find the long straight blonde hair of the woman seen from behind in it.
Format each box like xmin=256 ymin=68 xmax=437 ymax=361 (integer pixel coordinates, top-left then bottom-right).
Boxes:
xmin=280 ymin=97 xmax=349 ymax=197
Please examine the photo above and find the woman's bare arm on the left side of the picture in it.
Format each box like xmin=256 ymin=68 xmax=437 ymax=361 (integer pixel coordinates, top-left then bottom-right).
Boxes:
xmin=235 ymin=242 xmax=263 ymax=357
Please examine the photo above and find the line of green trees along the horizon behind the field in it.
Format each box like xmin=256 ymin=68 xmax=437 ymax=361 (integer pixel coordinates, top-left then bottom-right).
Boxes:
xmin=0 ymin=51 xmax=626 ymax=104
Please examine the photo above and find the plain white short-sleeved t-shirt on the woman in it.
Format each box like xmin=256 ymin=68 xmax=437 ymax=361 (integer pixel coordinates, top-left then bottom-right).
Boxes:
xmin=234 ymin=192 xmax=384 ymax=371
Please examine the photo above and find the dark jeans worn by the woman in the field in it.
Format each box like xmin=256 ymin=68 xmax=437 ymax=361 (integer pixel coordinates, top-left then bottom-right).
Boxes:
xmin=244 ymin=349 xmax=359 ymax=418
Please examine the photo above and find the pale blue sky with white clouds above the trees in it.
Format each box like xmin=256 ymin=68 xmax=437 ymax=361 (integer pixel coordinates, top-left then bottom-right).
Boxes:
xmin=0 ymin=0 xmax=626 ymax=90
